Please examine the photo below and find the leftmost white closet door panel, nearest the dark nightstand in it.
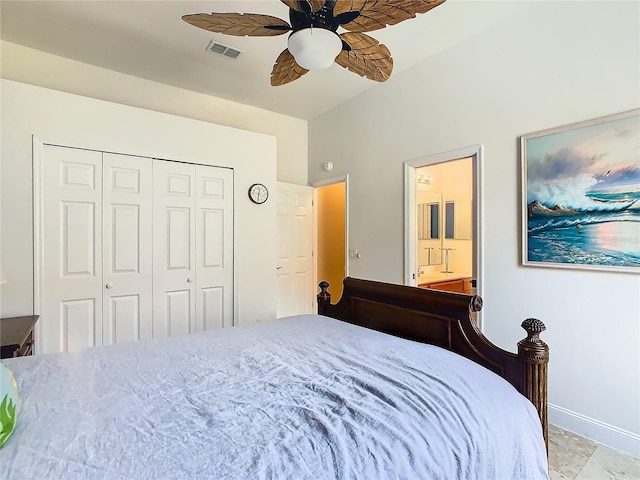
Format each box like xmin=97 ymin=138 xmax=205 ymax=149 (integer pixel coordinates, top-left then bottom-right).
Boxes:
xmin=38 ymin=145 xmax=102 ymax=353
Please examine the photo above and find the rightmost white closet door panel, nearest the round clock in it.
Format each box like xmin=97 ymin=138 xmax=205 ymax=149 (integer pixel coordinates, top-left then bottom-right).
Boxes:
xmin=195 ymin=166 xmax=233 ymax=331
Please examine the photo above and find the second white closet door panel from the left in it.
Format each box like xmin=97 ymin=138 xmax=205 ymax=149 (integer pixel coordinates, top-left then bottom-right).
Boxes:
xmin=102 ymin=153 xmax=153 ymax=344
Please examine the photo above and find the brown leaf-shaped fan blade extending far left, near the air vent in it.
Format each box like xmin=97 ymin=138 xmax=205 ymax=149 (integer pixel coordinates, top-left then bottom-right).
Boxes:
xmin=182 ymin=13 xmax=291 ymax=37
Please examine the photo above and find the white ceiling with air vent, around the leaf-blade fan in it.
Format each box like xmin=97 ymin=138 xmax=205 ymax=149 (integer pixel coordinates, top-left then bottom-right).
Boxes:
xmin=0 ymin=0 xmax=523 ymax=120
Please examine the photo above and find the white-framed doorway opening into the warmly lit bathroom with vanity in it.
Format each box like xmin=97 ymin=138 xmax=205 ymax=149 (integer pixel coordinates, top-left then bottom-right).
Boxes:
xmin=405 ymin=146 xmax=482 ymax=300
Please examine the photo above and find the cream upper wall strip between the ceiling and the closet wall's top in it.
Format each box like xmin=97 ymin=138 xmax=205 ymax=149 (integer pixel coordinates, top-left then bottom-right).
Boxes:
xmin=0 ymin=41 xmax=308 ymax=185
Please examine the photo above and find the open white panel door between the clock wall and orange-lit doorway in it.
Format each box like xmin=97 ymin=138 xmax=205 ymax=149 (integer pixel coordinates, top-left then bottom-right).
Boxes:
xmin=277 ymin=182 xmax=315 ymax=318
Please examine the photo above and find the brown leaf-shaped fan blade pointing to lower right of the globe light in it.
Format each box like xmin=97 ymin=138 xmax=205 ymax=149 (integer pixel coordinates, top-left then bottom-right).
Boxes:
xmin=336 ymin=32 xmax=393 ymax=82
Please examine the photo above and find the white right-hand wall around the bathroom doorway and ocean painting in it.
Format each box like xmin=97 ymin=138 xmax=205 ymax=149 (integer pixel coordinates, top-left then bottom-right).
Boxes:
xmin=309 ymin=1 xmax=640 ymax=457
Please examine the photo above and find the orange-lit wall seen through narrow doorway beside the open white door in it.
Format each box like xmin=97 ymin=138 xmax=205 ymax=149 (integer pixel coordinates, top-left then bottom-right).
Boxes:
xmin=316 ymin=182 xmax=346 ymax=303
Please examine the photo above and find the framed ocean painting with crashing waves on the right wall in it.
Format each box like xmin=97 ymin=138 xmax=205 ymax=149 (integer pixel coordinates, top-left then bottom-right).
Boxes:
xmin=520 ymin=109 xmax=640 ymax=273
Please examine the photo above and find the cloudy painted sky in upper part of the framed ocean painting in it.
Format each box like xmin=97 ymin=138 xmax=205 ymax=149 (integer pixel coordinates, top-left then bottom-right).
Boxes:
xmin=526 ymin=114 xmax=640 ymax=208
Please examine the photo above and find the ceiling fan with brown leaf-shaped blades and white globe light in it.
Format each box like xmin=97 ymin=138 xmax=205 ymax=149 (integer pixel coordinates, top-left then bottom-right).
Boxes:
xmin=182 ymin=0 xmax=445 ymax=86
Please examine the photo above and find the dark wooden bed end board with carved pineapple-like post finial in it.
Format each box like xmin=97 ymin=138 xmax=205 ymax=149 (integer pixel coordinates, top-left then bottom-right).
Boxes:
xmin=318 ymin=277 xmax=549 ymax=446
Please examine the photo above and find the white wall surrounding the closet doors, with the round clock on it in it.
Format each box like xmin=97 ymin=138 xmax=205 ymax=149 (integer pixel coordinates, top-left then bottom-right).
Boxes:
xmin=0 ymin=80 xmax=277 ymax=330
